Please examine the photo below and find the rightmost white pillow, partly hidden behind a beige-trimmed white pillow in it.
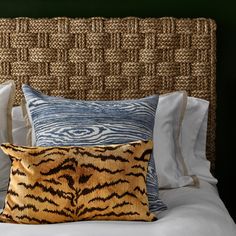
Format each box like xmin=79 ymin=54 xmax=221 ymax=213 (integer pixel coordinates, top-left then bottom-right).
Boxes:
xmin=180 ymin=97 xmax=217 ymax=184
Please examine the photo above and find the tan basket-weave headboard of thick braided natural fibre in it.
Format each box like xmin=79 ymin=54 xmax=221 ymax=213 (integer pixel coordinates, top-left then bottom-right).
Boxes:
xmin=0 ymin=17 xmax=216 ymax=168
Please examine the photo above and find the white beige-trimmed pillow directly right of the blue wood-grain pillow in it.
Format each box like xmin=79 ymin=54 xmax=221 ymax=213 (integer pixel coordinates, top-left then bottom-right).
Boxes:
xmin=153 ymin=92 xmax=198 ymax=188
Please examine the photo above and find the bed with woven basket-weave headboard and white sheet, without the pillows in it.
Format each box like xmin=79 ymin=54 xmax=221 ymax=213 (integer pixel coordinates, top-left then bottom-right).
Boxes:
xmin=0 ymin=17 xmax=236 ymax=236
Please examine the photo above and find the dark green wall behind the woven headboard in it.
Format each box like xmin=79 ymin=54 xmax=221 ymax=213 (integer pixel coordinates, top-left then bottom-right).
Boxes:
xmin=0 ymin=0 xmax=236 ymax=220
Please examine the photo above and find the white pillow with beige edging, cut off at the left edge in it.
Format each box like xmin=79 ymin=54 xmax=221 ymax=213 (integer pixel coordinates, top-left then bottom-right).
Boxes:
xmin=0 ymin=81 xmax=15 ymax=191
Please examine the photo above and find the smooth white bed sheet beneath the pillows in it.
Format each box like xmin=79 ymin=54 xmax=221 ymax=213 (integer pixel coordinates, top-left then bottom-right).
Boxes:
xmin=0 ymin=181 xmax=236 ymax=236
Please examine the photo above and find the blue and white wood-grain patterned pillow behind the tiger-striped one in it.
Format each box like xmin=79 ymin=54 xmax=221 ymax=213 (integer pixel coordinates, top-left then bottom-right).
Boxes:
xmin=22 ymin=85 xmax=166 ymax=212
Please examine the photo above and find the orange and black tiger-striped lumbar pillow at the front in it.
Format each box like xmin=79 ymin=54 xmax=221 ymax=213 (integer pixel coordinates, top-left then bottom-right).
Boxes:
xmin=0 ymin=141 xmax=156 ymax=224
